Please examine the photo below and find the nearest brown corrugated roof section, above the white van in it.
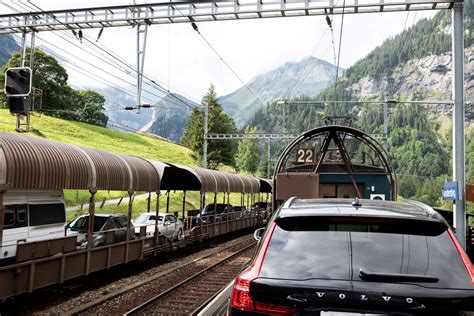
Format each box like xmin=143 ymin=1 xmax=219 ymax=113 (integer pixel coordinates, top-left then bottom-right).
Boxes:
xmin=0 ymin=132 xmax=160 ymax=191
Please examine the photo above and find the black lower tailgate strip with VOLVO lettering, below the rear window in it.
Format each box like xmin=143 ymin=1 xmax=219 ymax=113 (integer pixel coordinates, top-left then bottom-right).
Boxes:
xmin=250 ymin=278 xmax=474 ymax=315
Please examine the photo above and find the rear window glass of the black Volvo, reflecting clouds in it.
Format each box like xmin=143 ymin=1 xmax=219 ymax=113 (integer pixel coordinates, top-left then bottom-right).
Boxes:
xmin=260 ymin=217 xmax=469 ymax=287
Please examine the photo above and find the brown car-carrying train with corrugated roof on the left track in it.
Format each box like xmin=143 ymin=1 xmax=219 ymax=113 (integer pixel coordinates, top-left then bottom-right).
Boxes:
xmin=0 ymin=132 xmax=271 ymax=299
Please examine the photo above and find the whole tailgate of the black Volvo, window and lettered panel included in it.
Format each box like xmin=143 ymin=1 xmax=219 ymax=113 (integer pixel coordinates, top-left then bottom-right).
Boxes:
xmin=250 ymin=216 xmax=474 ymax=312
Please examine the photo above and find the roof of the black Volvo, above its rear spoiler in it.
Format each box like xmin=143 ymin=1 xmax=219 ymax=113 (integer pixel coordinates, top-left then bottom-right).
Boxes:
xmin=277 ymin=198 xmax=446 ymax=224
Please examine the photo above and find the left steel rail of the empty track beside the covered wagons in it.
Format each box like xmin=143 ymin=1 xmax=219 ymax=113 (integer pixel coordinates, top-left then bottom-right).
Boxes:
xmin=65 ymin=238 xmax=252 ymax=315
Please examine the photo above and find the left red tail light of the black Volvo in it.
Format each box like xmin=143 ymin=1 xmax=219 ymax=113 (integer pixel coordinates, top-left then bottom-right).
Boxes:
xmin=231 ymin=222 xmax=297 ymax=315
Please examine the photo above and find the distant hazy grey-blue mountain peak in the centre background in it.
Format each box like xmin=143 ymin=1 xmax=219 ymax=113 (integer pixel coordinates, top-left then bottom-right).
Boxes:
xmin=219 ymin=57 xmax=336 ymax=127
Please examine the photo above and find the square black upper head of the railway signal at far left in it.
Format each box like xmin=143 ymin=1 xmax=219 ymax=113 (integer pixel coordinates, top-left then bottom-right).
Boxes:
xmin=4 ymin=67 xmax=32 ymax=98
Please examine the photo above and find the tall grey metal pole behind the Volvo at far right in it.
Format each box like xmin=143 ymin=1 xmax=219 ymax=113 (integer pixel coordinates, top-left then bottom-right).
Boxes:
xmin=452 ymin=2 xmax=466 ymax=248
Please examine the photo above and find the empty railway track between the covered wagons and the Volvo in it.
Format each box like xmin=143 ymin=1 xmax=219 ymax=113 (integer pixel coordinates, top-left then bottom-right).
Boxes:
xmin=67 ymin=237 xmax=255 ymax=315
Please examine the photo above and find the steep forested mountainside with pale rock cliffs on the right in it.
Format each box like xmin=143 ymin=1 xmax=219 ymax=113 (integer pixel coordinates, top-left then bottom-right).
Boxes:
xmin=244 ymin=0 xmax=474 ymax=207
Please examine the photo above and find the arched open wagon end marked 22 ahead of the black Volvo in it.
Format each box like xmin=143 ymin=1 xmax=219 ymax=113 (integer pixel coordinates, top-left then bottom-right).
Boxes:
xmin=273 ymin=125 xmax=397 ymax=207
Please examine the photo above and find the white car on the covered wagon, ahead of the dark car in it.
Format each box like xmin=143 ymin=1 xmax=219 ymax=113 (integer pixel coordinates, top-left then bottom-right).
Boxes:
xmin=133 ymin=213 xmax=184 ymax=241
